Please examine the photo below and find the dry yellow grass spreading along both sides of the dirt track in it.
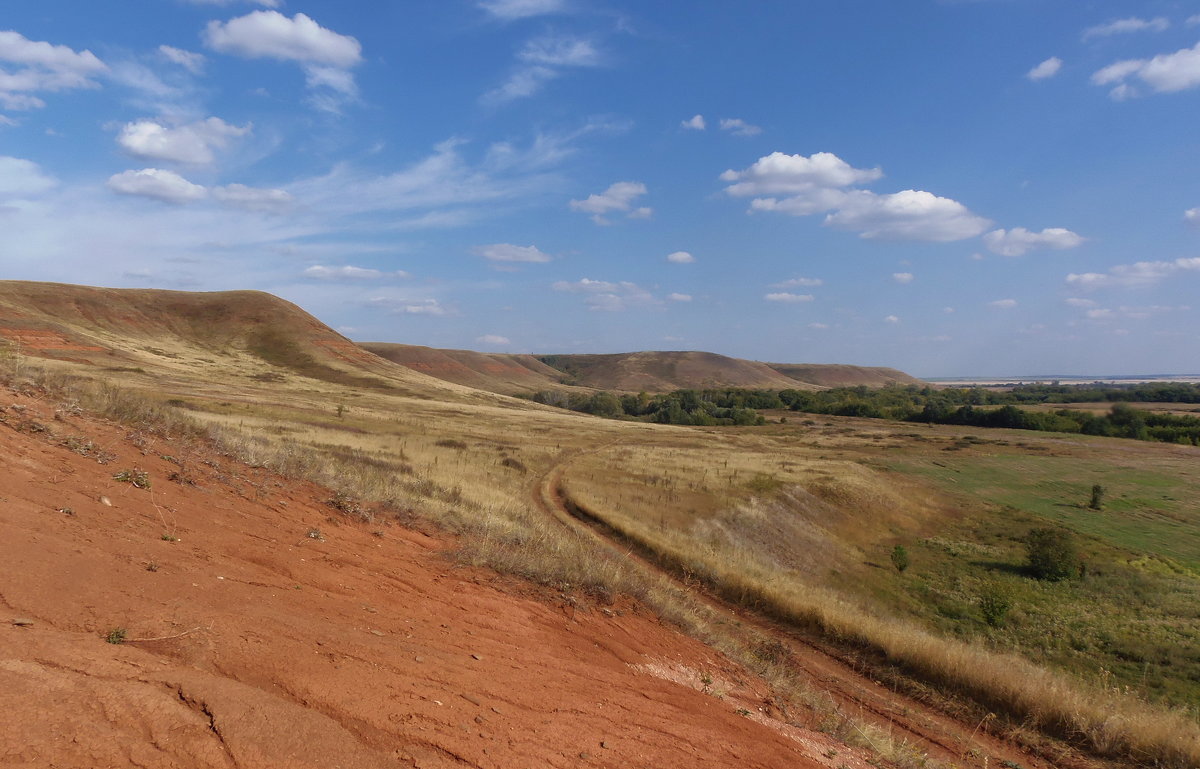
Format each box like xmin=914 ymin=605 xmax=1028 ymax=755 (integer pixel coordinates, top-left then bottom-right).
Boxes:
xmin=10 ymin=321 xmax=1200 ymax=767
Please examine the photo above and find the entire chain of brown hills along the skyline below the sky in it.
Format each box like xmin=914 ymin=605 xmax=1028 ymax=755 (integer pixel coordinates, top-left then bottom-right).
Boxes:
xmin=0 ymin=281 xmax=919 ymax=397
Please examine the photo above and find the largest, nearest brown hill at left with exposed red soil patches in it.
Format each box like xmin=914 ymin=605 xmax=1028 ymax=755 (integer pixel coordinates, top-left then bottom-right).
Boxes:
xmin=0 ymin=281 xmax=458 ymax=389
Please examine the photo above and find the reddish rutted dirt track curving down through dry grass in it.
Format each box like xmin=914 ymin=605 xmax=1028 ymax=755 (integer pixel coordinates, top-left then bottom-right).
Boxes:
xmin=530 ymin=449 xmax=1099 ymax=769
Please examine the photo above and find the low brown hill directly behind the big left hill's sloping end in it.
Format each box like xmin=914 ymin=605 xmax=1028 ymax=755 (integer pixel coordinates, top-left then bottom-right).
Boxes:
xmin=361 ymin=342 xmax=563 ymax=393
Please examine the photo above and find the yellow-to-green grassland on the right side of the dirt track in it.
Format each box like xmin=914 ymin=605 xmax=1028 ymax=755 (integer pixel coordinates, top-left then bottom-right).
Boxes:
xmin=564 ymin=420 xmax=1200 ymax=765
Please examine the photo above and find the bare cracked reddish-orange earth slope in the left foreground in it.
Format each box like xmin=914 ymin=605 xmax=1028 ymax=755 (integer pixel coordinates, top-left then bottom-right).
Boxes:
xmin=0 ymin=392 xmax=883 ymax=769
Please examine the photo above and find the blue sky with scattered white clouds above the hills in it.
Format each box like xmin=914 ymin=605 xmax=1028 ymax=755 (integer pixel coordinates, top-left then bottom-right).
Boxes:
xmin=0 ymin=0 xmax=1200 ymax=377
